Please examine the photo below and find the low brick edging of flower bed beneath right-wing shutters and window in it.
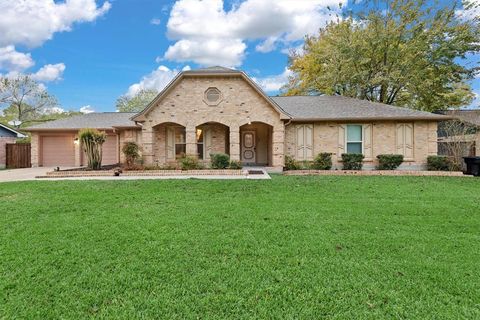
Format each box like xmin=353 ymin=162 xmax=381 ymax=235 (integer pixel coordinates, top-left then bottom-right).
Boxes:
xmin=283 ymin=170 xmax=470 ymax=177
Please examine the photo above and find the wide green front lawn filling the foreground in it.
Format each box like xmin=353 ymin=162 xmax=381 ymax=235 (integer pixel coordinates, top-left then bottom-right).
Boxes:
xmin=0 ymin=176 xmax=480 ymax=319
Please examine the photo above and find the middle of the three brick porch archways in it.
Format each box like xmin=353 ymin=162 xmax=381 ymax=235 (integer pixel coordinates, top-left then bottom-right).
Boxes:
xmin=195 ymin=122 xmax=230 ymax=162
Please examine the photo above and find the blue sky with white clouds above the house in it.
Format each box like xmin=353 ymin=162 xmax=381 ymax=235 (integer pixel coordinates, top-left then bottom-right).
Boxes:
xmin=0 ymin=0 xmax=480 ymax=112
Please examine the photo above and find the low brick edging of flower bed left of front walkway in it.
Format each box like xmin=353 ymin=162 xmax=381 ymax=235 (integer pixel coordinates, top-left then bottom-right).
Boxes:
xmin=36 ymin=169 xmax=247 ymax=178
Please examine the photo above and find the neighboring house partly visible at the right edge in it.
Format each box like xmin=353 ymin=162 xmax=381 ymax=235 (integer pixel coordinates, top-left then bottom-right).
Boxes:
xmin=438 ymin=109 xmax=480 ymax=156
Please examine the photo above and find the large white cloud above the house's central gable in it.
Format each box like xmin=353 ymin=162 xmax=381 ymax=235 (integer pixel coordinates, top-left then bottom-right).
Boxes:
xmin=165 ymin=0 xmax=340 ymax=66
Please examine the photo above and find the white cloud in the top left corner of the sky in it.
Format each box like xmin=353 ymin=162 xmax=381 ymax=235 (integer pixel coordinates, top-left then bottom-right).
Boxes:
xmin=0 ymin=0 xmax=111 ymax=47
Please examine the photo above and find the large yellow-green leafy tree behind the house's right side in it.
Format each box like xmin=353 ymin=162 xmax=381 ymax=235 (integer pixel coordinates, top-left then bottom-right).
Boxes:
xmin=284 ymin=0 xmax=480 ymax=111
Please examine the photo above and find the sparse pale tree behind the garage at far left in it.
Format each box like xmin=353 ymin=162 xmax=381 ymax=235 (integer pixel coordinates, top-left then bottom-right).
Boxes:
xmin=0 ymin=75 xmax=58 ymax=122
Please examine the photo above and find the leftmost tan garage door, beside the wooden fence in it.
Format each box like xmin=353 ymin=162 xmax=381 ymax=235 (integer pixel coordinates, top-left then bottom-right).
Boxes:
xmin=42 ymin=136 xmax=75 ymax=167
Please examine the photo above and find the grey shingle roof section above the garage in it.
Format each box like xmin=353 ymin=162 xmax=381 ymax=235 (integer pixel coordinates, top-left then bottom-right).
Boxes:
xmin=25 ymin=112 xmax=137 ymax=131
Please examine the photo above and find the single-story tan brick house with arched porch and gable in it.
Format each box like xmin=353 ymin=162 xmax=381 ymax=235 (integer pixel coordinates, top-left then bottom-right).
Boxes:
xmin=23 ymin=67 xmax=448 ymax=168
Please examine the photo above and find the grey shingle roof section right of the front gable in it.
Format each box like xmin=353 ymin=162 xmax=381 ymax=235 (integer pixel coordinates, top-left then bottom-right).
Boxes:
xmin=270 ymin=95 xmax=451 ymax=121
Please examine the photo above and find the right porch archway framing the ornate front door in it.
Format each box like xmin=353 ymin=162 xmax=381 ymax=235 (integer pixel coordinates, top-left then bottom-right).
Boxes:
xmin=240 ymin=122 xmax=273 ymax=166
